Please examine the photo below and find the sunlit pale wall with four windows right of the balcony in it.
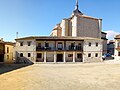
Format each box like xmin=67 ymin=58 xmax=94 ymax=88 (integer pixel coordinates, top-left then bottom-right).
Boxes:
xmin=83 ymin=40 xmax=102 ymax=62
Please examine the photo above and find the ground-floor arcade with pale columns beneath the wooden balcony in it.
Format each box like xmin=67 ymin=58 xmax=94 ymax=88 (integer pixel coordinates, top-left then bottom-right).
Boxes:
xmin=36 ymin=51 xmax=83 ymax=63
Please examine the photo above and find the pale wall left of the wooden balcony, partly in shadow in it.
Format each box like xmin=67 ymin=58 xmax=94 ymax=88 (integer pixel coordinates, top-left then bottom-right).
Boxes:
xmin=15 ymin=39 xmax=36 ymax=61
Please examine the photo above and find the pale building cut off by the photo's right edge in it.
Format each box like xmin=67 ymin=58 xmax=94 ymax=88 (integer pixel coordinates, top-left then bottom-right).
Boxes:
xmin=114 ymin=35 xmax=120 ymax=60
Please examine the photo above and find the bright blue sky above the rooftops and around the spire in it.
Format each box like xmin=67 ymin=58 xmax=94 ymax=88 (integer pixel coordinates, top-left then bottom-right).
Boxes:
xmin=0 ymin=0 xmax=120 ymax=41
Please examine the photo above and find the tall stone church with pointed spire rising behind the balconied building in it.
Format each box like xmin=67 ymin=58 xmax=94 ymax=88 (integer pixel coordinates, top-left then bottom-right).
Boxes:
xmin=50 ymin=0 xmax=107 ymax=54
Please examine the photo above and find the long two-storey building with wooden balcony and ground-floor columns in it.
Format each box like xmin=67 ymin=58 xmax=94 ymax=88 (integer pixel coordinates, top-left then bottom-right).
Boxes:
xmin=15 ymin=37 xmax=102 ymax=63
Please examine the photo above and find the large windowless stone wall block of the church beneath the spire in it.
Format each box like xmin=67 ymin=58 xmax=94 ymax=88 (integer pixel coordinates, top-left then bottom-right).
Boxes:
xmin=72 ymin=16 xmax=101 ymax=38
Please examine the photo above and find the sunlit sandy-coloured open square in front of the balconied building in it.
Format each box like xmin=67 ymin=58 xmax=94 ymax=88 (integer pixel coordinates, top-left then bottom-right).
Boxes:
xmin=0 ymin=63 xmax=120 ymax=90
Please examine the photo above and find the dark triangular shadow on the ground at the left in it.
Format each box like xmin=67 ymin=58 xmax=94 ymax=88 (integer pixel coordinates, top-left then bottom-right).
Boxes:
xmin=0 ymin=64 xmax=33 ymax=74
